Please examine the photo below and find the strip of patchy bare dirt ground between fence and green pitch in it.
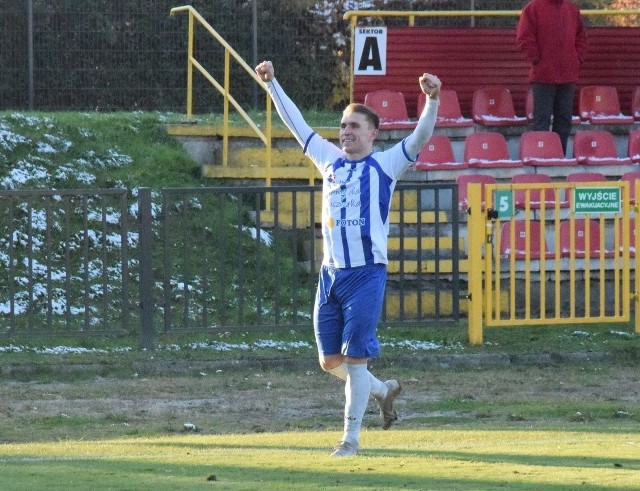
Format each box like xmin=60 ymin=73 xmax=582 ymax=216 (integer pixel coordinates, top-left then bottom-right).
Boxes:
xmin=0 ymin=360 xmax=640 ymax=442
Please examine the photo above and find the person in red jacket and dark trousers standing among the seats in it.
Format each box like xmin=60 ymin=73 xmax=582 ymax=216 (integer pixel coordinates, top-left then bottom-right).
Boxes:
xmin=516 ymin=0 xmax=587 ymax=154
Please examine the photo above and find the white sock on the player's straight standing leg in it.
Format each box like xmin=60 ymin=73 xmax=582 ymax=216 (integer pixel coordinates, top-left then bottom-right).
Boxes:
xmin=342 ymin=363 xmax=371 ymax=445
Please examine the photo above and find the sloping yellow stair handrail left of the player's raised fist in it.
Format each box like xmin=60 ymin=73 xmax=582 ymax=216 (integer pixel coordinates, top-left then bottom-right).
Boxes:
xmin=171 ymin=5 xmax=272 ymax=190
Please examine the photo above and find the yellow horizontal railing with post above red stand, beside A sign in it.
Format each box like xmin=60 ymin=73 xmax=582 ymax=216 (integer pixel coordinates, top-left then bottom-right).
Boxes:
xmin=343 ymin=9 xmax=640 ymax=102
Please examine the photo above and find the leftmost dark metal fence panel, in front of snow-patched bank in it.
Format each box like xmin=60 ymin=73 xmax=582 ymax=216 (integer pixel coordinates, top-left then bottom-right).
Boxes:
xmin=0 ymin=190 xmax=132 ymax=337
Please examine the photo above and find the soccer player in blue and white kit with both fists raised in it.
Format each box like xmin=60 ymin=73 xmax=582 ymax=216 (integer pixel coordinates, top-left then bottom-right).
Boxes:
xmin=256 ymin=61 xmax=442 ymax=457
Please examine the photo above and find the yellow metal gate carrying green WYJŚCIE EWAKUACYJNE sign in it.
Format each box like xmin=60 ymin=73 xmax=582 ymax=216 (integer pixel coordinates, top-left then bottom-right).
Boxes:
xmin=467 ymin=181 xmax=640 ymax=345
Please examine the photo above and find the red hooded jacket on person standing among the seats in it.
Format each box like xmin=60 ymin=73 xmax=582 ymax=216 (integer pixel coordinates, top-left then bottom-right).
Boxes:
xmin=516 ymin=0 xmax=587 ymax=84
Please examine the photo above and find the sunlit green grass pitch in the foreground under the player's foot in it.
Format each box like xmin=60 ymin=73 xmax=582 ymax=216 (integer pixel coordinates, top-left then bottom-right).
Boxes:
xmin=0 ymin=425 xmax=640 ymax=491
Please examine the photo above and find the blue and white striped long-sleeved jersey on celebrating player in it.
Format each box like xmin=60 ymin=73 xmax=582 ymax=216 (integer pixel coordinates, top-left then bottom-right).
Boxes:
xmin=267 ymin=79 xmax=438 ymax=268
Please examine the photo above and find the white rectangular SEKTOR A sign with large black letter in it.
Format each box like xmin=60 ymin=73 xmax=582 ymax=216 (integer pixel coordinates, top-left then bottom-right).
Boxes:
xmin=353 ymin=27 xmax=387 ymax=75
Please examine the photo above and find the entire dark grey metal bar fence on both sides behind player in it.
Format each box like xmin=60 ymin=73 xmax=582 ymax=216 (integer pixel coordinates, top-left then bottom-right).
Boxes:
xmin=0 ymin=184 xmax=460 ymax=348
